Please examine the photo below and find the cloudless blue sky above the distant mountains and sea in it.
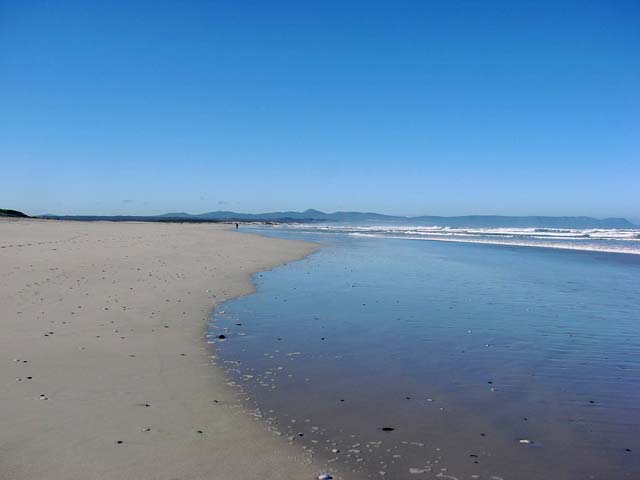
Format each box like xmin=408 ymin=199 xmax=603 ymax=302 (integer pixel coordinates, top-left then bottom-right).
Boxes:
xmin=0 ymin=0 xmax=640 ymax=221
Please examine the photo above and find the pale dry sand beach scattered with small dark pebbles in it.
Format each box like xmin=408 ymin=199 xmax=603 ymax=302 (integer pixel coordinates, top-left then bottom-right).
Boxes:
xmin=0 ymin=220 xmax=318 ymax=480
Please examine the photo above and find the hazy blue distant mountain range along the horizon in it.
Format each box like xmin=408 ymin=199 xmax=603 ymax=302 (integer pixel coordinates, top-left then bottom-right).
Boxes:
xmin=45 ymin=209 xmax=636 ymax=228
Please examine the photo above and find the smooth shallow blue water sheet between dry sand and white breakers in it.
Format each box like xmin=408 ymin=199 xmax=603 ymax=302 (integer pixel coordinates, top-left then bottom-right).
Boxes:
xmin=210 ymin=230 xmax=640 ymax=480
